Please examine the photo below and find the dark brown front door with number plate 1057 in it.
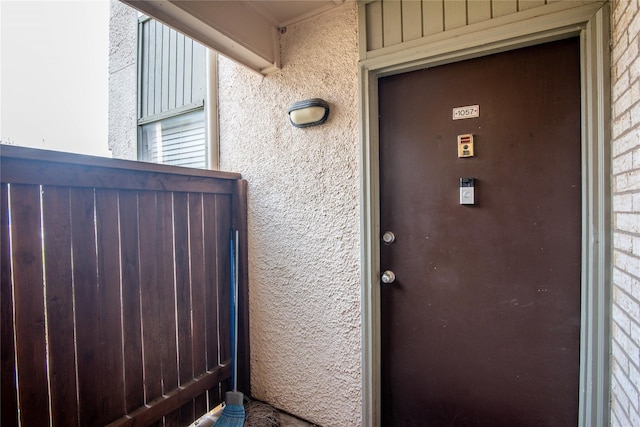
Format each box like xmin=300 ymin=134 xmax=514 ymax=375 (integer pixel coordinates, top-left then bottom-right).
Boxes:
xmin=379 ymin=38 xmax=582 ymax=427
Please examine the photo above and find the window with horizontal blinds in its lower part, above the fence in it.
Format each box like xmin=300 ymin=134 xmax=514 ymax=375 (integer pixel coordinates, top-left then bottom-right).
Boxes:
xmin=138 ymin=17 xmax=216 ymax=168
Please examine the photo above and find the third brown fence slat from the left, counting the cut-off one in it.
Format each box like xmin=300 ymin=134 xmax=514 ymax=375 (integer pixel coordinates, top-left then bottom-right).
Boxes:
xmin=42 ymin=187 xmax=82 ymax=427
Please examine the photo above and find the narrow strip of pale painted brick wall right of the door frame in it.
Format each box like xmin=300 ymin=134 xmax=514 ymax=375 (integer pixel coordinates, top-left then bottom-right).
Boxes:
xmin=611 ymin=0 xmax=640 ymax=427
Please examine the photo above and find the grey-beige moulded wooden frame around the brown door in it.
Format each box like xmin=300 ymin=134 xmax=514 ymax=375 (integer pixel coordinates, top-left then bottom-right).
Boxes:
xmin=358 ymin=1 xmax=611 ymax=427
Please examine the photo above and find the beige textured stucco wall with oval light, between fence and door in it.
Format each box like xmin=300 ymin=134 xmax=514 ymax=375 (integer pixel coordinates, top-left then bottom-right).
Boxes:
xmin=219 ymin=4 xmax=361 ymax=427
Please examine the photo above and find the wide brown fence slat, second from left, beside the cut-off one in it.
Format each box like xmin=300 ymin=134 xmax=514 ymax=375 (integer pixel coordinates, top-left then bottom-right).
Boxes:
xmin=9 ymin=185 xmax=49 ymax=426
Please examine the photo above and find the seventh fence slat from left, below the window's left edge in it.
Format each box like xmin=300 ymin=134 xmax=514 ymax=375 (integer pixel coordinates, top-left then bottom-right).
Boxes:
xmin=138 ymin=192 xmax=162 ymax=403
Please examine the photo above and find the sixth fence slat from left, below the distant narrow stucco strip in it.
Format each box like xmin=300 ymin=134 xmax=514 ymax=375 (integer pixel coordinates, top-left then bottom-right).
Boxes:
xmin=119 ymin=191 xmax=144 ymax=413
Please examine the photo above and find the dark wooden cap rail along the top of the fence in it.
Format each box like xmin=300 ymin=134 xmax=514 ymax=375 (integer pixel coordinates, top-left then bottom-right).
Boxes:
xmin=0 ymin=144 xmax=242 ymax=181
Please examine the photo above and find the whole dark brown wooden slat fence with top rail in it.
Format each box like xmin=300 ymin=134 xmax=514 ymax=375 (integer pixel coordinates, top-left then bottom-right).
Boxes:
xmin=0 ymin=146 xmax=250 ymax=427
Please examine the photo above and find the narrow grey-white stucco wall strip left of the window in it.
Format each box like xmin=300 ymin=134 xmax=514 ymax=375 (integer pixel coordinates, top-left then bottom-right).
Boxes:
xmin=109 ymin=0 xmax=138 ymax=160
